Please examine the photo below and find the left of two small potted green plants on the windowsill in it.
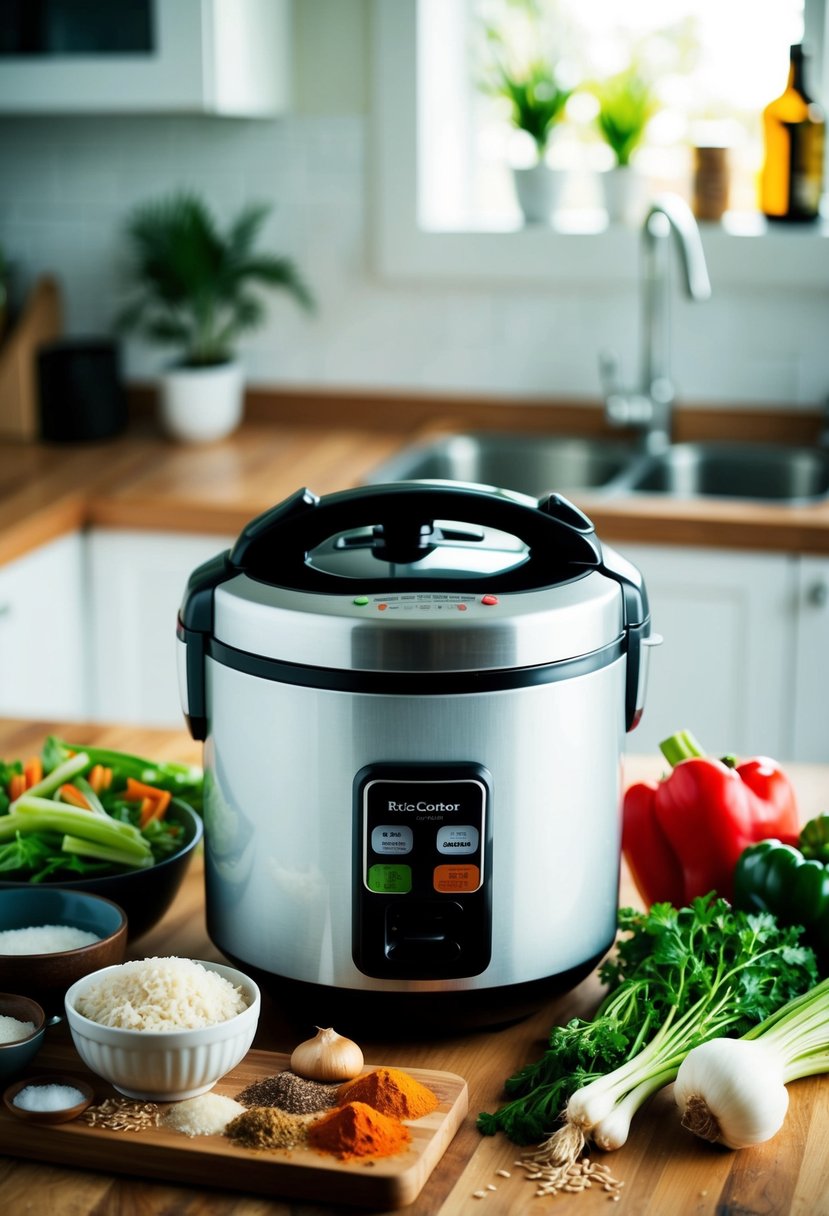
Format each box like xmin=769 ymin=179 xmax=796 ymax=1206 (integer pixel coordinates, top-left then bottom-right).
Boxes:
xmin=481 ymin=27 xmax=573 ymax=224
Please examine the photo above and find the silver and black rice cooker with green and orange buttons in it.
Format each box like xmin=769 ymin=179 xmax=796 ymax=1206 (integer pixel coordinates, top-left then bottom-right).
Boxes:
xmin=177 ymin=482 xmax=653 ymax=1029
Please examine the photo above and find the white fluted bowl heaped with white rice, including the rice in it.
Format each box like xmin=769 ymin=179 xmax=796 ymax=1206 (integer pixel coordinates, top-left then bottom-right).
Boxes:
xmin=64 ymin=957 xmax=260 ymax=1102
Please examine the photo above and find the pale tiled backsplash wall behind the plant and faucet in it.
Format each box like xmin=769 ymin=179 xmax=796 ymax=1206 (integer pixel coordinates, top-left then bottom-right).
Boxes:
xmin=0 ymin=114 xmax=829 ymax=406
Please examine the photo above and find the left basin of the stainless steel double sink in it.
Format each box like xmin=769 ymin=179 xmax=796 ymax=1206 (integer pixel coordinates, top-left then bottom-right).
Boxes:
xmin=371 ymin=432 xmax=637 ymax=497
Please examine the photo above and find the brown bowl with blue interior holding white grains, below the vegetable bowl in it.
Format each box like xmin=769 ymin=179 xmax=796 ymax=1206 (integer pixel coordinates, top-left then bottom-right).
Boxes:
xmin=0 ymin=886 xmax=126 ymax=1013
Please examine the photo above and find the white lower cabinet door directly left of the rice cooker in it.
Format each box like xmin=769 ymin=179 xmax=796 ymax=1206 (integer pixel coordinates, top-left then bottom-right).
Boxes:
xmin=88 ymin=529 xmax=232 ymax=727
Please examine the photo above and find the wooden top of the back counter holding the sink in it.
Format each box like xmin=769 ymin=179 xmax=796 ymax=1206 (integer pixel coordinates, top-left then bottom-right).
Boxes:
xmin=0 ymin=410 xmax=829 ymax=564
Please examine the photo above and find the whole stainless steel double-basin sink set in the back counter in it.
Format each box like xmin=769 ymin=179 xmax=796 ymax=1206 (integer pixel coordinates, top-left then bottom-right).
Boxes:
xmin=367 ymin=432 xmax=829 ymax=506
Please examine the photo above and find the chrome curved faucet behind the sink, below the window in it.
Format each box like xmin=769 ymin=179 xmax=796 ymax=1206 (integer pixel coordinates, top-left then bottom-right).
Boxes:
xmin=599 ymin=195 xmax=711 ymax=451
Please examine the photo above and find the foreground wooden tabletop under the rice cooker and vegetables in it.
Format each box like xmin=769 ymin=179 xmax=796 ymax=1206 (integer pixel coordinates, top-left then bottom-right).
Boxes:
xmin=0 ymin=721 xmax=829 ymax=1216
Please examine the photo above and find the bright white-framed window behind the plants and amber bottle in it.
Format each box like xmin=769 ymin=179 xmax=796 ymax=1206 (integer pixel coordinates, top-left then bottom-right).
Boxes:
xmin=374 ymin=0 xmax=829 ymax=286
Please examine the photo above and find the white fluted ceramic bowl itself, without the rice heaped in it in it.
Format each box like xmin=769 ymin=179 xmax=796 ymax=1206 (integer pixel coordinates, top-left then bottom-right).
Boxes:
xmin=66 ymin=959 xmax=261 ymax=1102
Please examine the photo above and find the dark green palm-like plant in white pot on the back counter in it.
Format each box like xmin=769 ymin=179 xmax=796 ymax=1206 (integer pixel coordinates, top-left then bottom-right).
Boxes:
xmin=117 ymin=193 xmax=312 ymax=441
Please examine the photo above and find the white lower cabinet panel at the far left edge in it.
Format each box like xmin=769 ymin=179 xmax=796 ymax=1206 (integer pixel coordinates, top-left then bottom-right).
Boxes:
xmin=0 ymin=533 xmax=91 ymax=720
